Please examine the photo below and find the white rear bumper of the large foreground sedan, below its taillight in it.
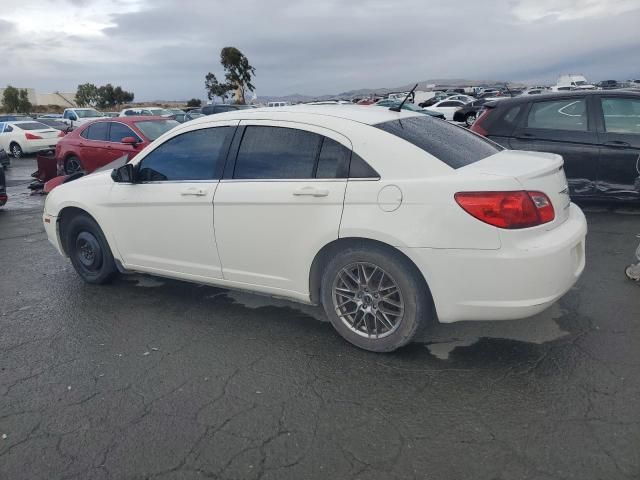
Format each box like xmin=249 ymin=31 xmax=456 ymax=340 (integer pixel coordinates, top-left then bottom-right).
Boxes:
xmin=401 ymin=204 xmax=587 ymax=323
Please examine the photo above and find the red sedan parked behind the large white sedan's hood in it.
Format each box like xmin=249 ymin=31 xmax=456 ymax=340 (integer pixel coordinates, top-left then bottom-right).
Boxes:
xmin=56 ymin=116 xmax=180 ymax=175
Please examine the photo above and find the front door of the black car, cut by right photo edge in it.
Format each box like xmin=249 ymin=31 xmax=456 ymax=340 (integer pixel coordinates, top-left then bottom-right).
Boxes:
xmin=595 ymin=96 xmax=640 ymax=200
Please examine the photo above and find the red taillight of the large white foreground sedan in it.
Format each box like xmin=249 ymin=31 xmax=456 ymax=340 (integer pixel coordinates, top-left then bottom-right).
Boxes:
xmin=455 ymin=190 xmax=555 ymax=229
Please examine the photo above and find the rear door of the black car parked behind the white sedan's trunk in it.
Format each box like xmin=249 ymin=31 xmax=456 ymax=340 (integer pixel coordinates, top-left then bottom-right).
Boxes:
xmin=509 ymin=96 xmax=599 ymax=197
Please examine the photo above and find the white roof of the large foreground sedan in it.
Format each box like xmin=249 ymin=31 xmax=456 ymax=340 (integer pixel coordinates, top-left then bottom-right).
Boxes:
xmin=185 ymin=104 xmax=420 ymax=125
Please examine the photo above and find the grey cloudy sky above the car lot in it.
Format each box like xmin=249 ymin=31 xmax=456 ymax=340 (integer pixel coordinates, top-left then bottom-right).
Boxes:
xmin=0 ymin=0 xmax=640 ymax=100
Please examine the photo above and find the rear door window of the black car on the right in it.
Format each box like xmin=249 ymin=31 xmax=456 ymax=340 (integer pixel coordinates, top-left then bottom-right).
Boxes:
xmin=527 ymin=98 xmax=588 ymax=132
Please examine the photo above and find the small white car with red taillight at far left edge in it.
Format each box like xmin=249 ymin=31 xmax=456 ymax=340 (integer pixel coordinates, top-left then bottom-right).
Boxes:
xmin=0 ymin=120 xmax=64 ymax=158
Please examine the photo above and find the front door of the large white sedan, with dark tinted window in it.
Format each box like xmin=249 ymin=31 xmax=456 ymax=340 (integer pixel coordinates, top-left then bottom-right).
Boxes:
xmin=106 ymin=121 xmax=237 ymax=280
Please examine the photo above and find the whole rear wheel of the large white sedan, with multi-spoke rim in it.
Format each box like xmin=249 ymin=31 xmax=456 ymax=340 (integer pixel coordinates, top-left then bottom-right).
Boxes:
xmin=321 ymin=245 xmax=433 ymax=352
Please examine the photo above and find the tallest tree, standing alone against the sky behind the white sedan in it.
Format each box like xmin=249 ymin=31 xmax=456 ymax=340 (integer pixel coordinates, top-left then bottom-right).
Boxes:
xmin=205 ymin=47 xmax=256 ymax=104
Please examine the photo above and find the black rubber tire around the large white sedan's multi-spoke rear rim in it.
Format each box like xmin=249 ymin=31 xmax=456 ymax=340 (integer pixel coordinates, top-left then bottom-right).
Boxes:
xmin=320 ymin=243 xmax=434 ymax=352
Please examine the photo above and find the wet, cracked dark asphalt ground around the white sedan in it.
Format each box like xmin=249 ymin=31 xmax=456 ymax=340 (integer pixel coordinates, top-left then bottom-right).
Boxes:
xmin=0 ymin=156 xmax=640 ymax=480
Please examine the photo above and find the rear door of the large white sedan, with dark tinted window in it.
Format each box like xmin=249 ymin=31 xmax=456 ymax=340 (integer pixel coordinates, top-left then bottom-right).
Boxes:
xmin=214 ymin=120 xmax=351 ymax=295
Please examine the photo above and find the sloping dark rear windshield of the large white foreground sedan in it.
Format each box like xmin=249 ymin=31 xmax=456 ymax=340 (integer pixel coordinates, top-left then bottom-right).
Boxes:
xmin=374 ymin=115 xmax=501 ymax=168
